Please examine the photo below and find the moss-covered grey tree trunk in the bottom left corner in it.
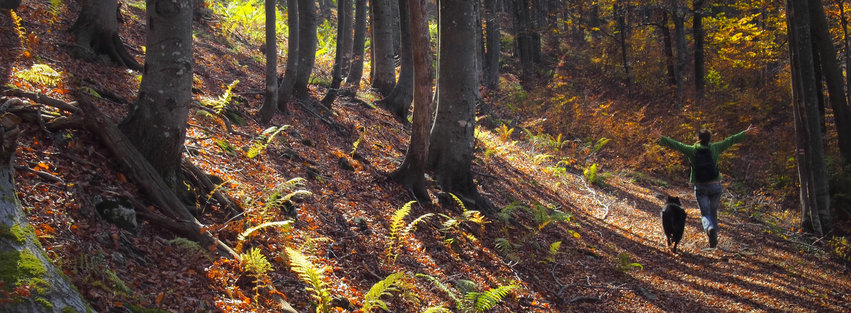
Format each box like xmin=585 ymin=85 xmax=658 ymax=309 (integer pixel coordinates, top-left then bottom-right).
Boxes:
xmin=0 ymin=121 xmax=92 ymax=313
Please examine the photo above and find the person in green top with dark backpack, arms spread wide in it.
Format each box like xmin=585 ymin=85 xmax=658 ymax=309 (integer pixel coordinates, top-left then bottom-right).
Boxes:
xmin=654 ymin=125 xmax=756 ymax=249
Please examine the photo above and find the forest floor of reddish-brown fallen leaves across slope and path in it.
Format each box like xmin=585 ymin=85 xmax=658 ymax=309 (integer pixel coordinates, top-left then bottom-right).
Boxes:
xmin=0 ymin=1 xmax=851 ymax=312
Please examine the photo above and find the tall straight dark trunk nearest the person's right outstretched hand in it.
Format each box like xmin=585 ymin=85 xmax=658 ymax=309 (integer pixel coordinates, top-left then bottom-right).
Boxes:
xmin=786 ymin=0 xmax=831 ymax=235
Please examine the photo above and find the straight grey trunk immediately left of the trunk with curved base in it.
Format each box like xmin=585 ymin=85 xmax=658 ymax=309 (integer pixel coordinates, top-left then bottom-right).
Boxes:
xmin=371 ymin=0 xmax=396 ymax=95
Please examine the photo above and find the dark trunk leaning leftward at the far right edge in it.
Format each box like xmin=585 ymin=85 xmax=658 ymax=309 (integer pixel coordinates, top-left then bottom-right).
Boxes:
xmin=809 ymin=0 xmax=851 ymax=164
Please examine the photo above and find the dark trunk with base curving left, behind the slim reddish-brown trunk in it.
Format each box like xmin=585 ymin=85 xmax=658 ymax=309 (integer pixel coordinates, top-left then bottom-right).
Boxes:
xmin=381 ymin=1 xmax=414 ymax=124
